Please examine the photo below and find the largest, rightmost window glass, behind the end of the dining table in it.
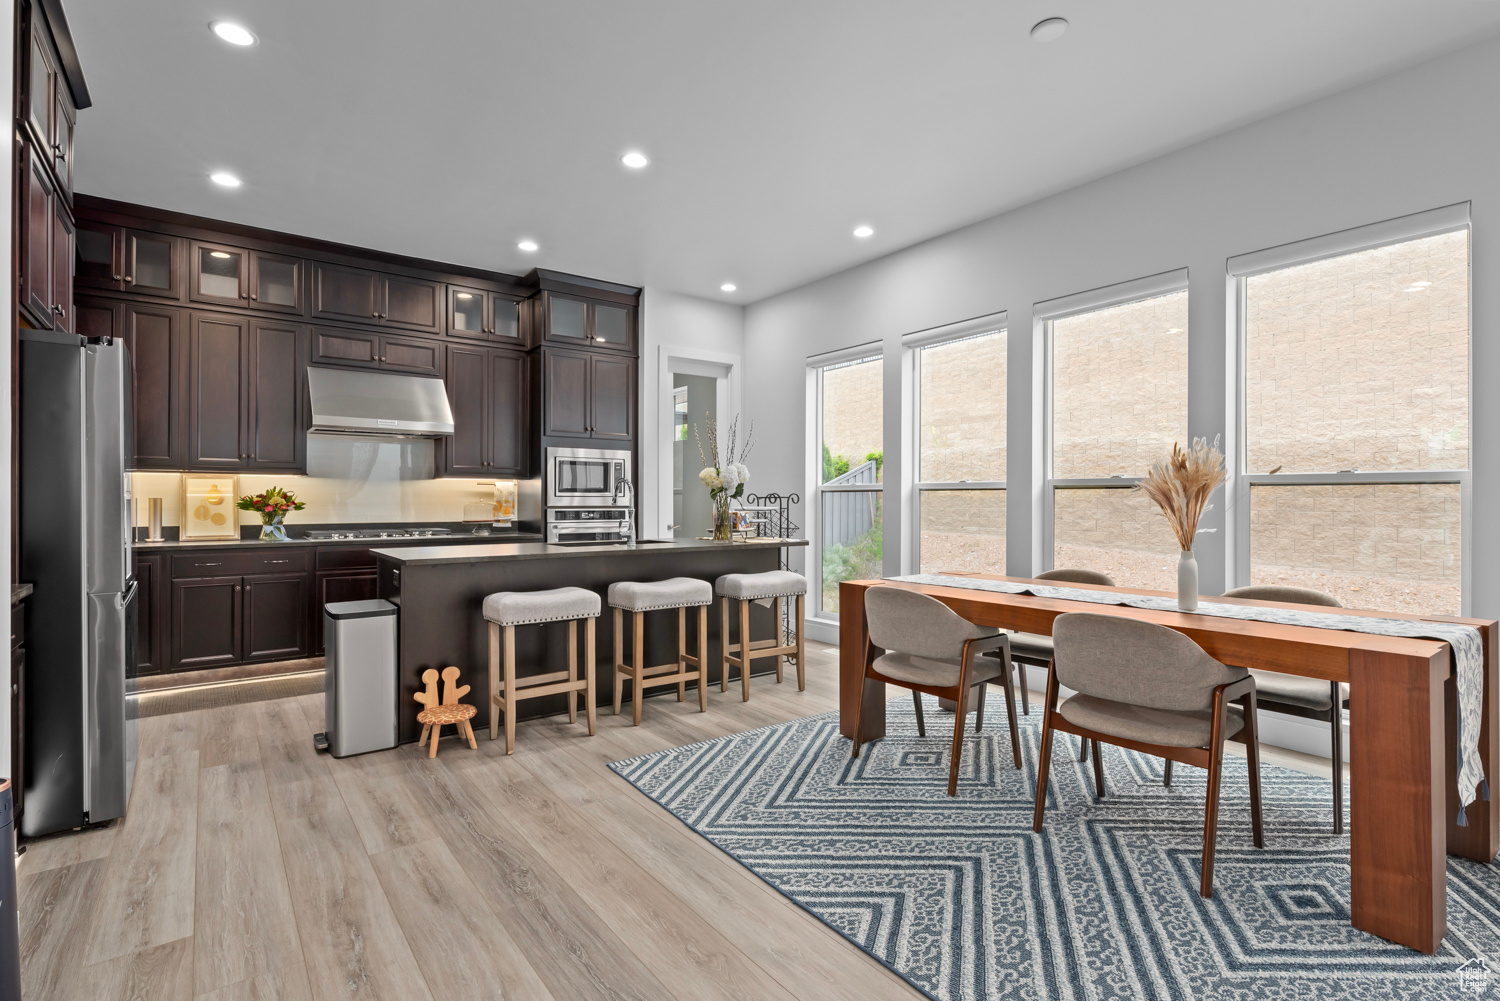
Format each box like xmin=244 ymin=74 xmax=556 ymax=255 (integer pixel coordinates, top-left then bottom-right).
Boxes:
xmin=1230 ymin=219 xmax=1470 ymax=615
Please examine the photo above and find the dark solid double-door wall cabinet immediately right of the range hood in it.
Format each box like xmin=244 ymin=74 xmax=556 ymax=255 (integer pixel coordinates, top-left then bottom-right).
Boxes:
xmin=441 ymin=344 xmax=531 ymax=477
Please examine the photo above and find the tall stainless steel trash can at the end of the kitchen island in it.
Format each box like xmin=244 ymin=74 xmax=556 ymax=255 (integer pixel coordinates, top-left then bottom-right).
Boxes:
xmin=323 ymin=597 xmax=398 ymax=758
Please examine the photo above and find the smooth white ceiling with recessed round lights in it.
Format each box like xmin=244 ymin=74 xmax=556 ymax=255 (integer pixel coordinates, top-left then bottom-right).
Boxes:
xmin=65 ymin=0 xmax=1500 ymax=302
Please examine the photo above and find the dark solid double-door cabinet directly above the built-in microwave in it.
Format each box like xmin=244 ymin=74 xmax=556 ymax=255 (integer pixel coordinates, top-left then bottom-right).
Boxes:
xmin=542 ymin=348 xmax=636 ymax=440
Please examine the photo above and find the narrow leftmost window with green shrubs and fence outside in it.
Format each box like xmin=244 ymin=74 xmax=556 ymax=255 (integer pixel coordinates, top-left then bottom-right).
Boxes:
xmin=813 ymin=354 xmax=885 ymax=614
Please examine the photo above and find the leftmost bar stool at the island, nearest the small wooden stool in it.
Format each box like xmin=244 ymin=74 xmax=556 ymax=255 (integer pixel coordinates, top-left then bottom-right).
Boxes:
xmin=483 ymin=587 xmax=599 ymax=755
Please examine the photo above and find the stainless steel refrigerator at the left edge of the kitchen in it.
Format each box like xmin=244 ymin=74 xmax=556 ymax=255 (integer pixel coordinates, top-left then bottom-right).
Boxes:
xmin=20 ymin=330 xmax=137 ymax=837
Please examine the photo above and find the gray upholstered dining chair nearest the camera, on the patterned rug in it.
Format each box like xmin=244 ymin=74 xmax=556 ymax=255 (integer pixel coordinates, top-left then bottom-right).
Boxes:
xmin=1032 ymin=612 xmax=1265 ymax=896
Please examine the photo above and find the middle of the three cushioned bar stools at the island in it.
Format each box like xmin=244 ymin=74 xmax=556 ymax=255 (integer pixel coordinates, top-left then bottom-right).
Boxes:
xmin=609 ymin=576 xmax=714 ymax=726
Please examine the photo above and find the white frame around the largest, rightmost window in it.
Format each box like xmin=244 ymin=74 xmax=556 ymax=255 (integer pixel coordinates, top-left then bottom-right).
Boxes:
xmin=1226 ymin=201 xmax=1475 ymax=615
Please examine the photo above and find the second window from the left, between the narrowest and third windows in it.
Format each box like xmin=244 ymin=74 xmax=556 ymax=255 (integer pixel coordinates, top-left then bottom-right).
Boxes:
xmin=912 ymin=330 xmax=1007 ymax=573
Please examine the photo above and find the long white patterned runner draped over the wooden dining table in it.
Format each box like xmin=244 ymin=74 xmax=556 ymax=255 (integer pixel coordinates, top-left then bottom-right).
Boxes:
xmin=887 ymin=573 xmax=1490 ymax=825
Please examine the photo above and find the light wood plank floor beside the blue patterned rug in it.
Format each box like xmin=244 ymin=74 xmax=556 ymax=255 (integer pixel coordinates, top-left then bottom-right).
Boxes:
xmin=20 ymin=644 xmax=1328 ymax=1001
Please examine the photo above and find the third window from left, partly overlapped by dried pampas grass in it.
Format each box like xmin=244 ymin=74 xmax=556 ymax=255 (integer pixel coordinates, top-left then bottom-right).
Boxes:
xmin=1037 ymin=272 xmax=1188 ymax=591
